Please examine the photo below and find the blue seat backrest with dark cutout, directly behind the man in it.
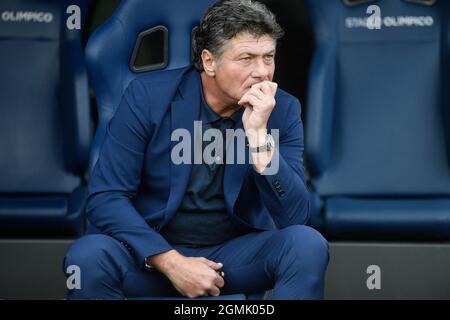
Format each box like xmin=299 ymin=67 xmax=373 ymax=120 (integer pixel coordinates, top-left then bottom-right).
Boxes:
xmin=86 ymin=0 xmax=214 ymax=170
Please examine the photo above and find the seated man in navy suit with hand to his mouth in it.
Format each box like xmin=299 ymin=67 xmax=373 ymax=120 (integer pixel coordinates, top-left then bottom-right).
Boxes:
xmin=64 ymin=0 xmax=328 ymax=299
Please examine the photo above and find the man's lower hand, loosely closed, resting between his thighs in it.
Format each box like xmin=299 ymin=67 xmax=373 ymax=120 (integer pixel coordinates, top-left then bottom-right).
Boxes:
xmin=148 ymin=250 xmax=225 ymax=298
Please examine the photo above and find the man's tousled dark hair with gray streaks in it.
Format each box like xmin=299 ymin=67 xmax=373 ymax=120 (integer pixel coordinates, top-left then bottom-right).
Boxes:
xmin=192 ymin=0 xmax=284 ymax=71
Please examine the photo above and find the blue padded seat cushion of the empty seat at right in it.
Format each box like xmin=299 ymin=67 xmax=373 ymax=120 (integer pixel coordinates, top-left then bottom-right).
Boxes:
xmin=325 ymin=197 xmax=450 ymax=240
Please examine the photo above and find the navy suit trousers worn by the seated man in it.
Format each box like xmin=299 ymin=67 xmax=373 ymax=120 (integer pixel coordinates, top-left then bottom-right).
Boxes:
xmin=64 ymin=225 xmax=329 ymax=300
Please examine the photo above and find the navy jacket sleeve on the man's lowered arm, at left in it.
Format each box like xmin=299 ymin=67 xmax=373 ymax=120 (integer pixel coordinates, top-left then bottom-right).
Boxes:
xmin=87 ymin=80 xmax=172 ymax=266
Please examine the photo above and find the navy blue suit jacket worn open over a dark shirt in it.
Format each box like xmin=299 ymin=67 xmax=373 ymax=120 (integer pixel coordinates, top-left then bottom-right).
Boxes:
xmin=87 ymin=67 xmax=309 ymax=265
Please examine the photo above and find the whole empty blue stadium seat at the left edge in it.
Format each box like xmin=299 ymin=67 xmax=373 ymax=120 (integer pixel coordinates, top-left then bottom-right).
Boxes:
xmin=0 ymin=0 xmax=91 ymax=237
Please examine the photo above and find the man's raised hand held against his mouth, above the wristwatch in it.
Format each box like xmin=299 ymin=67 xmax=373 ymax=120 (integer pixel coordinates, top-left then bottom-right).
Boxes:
xmin=238 ymin=81 xmax=278 ymax=147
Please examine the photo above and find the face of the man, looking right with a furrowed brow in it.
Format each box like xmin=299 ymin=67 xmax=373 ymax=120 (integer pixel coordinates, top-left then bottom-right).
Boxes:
xmin=215 ymin=33 xmax=276 ymax=102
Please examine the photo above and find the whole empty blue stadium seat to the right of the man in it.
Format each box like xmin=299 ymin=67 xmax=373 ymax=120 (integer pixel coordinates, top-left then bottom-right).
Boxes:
xmin=305 ymin=0 xmax=450 ymax=240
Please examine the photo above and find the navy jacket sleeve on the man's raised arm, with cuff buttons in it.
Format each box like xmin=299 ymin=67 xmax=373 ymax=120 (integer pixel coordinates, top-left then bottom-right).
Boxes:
xmin=253 ymin=99 xmax=309 ymax=228
